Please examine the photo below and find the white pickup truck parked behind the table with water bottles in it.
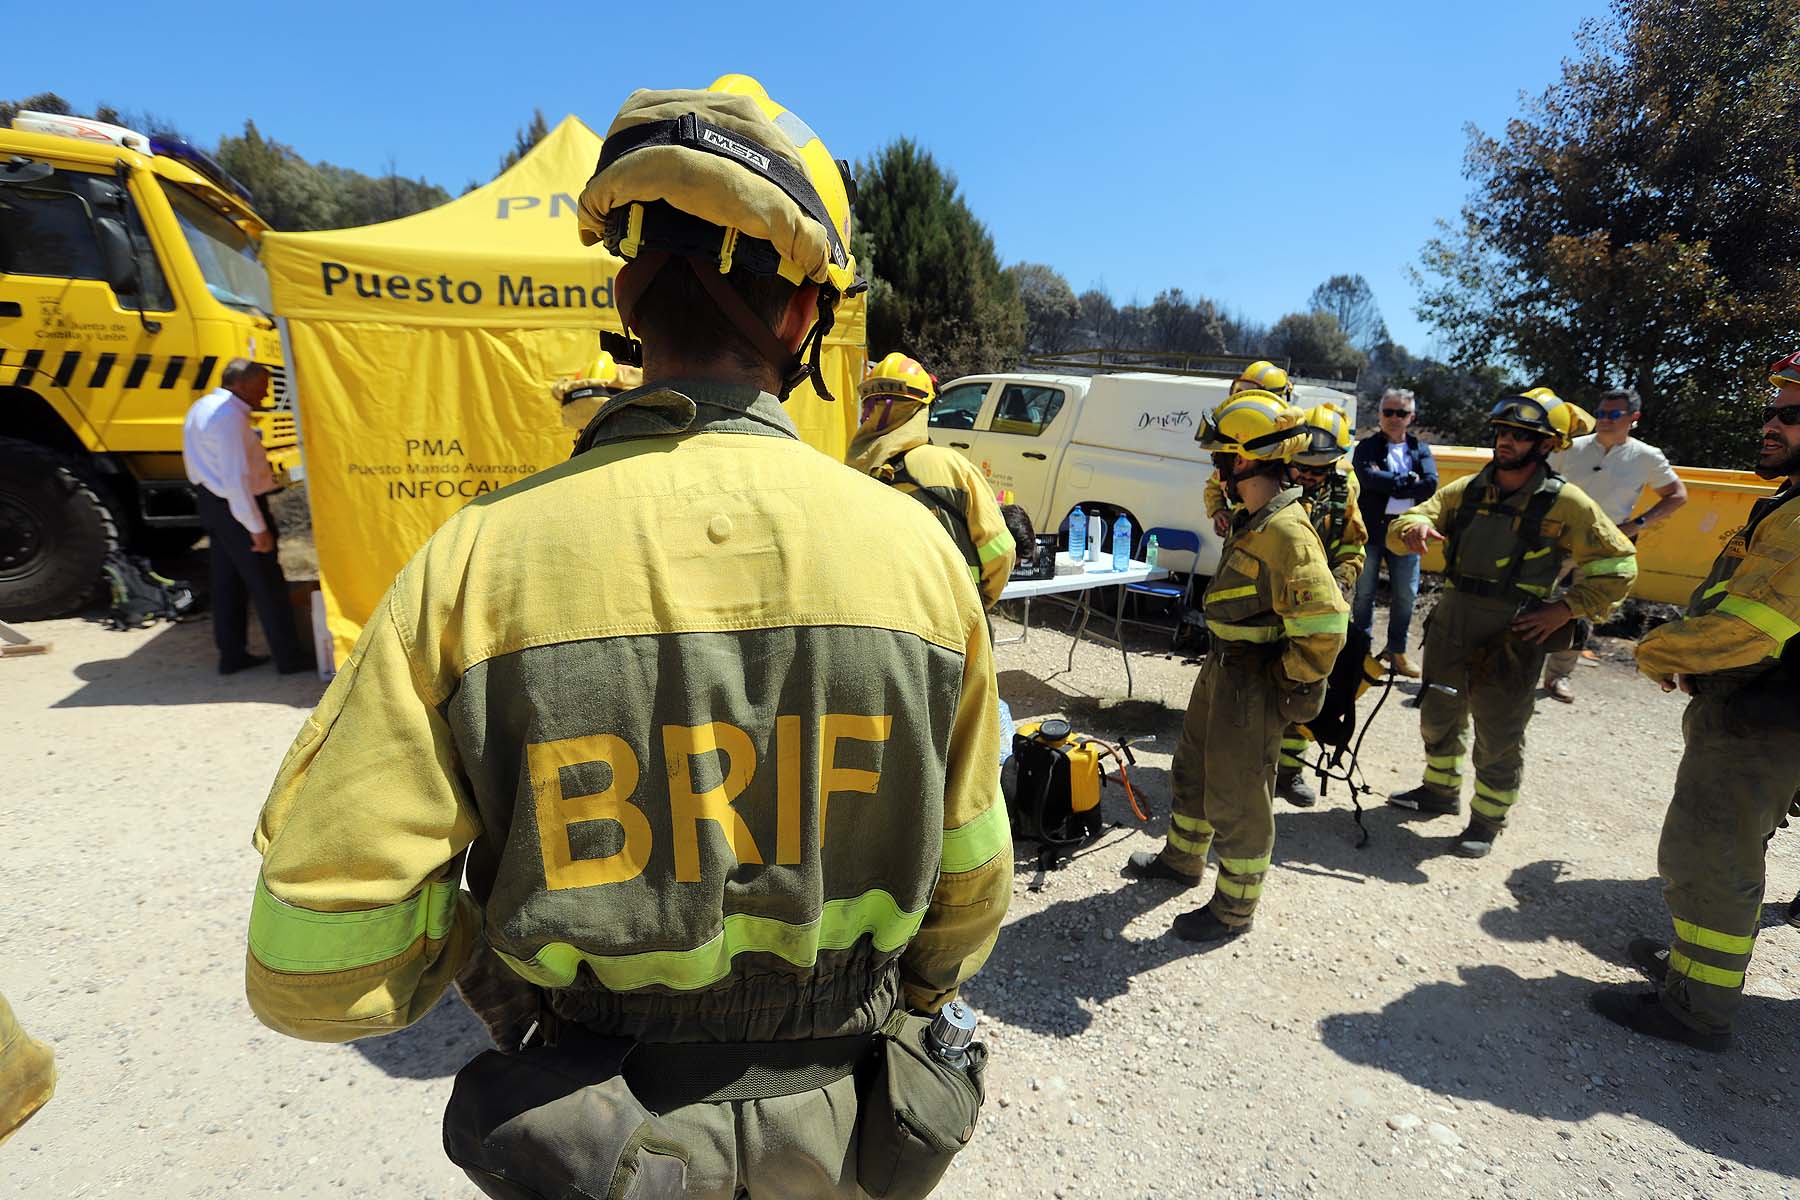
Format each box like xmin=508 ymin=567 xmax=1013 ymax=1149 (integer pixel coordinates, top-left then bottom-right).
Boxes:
xmin=931 ymin=372 xmax=1355 ymax=576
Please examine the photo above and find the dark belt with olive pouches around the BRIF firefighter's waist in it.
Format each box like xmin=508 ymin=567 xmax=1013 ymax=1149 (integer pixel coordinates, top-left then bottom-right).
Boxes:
xmin=443 ymin=1009 xmax=986 ymax=1200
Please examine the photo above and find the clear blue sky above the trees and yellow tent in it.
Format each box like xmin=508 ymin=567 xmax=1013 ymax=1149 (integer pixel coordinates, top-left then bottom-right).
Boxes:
xmin=17 ymin=0 xmax=1604 ymax=353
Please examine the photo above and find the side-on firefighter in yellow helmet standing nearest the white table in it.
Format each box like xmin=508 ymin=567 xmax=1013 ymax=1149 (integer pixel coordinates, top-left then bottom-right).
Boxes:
xmin=1125 ymin=389 xmax=1350 ymax=943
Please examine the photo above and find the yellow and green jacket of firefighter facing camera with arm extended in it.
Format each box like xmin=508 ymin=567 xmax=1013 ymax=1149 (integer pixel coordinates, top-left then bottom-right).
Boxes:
xmin=1388 ymin=464 xmax=1638 ymax=619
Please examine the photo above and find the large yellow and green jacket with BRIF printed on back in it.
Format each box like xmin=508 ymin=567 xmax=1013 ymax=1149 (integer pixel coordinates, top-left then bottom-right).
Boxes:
xmin=247 ymin=383 xmax=1012 ymax=1042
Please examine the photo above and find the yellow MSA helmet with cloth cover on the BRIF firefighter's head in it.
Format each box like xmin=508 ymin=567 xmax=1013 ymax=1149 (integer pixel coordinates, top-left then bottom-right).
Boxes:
xmin=578 ymin=76 xmax=860 ymax=399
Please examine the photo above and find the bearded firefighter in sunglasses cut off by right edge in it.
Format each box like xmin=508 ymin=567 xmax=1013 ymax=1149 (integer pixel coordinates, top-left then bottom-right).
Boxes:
xmin=1591 ymin=353 xmax=1800 ymax=1051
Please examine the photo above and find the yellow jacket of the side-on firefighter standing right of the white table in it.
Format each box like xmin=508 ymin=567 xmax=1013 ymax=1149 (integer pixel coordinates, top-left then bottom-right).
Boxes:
xmin=1201 ymin=488 xmax=1350 ymax=684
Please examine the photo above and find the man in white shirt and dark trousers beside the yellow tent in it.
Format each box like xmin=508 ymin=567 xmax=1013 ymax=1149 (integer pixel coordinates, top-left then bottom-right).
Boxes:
xmin=182 ymin=358 xmax=313 ymax=675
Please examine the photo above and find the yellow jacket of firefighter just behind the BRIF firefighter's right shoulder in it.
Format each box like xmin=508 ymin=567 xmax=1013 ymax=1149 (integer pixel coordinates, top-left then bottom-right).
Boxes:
xmin=848 ymin=405 xmax=1017 ymax=608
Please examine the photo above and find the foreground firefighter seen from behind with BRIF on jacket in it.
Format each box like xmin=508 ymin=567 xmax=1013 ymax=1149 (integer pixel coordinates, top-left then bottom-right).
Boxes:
xmin=247 ymin=76 xmax=1012 ymax=1198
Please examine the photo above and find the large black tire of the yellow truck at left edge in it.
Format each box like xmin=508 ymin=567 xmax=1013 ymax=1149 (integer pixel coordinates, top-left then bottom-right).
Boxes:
xmin=0 ymin=437 xmax=119 ymax=621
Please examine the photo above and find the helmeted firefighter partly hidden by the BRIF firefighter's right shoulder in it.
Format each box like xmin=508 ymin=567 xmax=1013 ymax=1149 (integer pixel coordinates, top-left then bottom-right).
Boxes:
xmin=848 ymin=351 xmax=1015 ymax=608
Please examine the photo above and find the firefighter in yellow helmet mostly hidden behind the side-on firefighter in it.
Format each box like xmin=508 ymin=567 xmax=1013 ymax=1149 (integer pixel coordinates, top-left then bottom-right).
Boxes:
xmin=1274 ymin=403 xmax=1368 ymax=808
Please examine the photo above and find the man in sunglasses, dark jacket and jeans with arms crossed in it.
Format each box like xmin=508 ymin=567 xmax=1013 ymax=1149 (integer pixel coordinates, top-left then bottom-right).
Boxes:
xmin=1350 ymin=387 xmax=1438 ymax=678
